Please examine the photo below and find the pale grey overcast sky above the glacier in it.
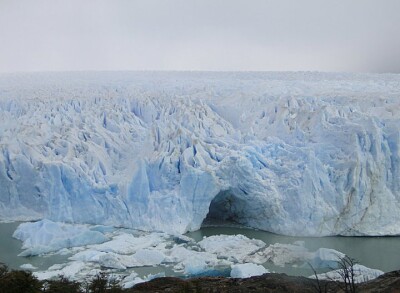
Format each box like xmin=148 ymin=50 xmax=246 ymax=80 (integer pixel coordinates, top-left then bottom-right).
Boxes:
xmin=0 ymin=0 xmax=400 ymax=73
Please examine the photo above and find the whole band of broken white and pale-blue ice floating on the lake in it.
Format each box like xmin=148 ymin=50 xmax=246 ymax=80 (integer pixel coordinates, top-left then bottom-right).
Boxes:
xmin=11 ymin=220 xmax=384 ymax=287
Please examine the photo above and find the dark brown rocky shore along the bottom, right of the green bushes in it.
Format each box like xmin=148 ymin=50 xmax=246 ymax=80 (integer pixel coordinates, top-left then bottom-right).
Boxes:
xmin=127 ymin=271 xmax=400 ymax=293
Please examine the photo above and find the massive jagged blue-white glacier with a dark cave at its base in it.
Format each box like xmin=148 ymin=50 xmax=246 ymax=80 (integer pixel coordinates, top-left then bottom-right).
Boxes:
xmin=0 ymin=72 xmax=400 ymax=236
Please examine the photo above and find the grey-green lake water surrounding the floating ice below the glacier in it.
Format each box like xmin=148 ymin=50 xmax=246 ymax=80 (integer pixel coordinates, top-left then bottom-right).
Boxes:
xmin=0 ymin=222 xmax=400 ymax=276
